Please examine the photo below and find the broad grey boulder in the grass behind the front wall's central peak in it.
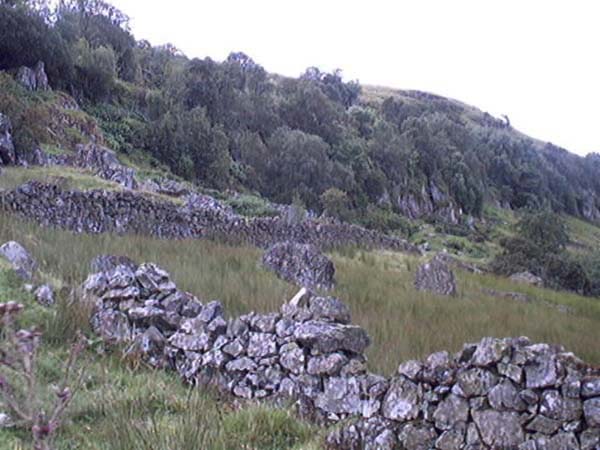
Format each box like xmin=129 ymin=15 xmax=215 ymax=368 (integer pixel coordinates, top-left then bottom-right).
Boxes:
xmin=263 ymin=241 xmax=335 ymax=289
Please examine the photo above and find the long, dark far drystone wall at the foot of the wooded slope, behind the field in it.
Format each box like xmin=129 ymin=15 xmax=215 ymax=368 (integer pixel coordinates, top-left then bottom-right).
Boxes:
xmin=0 ymin=181 xmax=418 ymax=253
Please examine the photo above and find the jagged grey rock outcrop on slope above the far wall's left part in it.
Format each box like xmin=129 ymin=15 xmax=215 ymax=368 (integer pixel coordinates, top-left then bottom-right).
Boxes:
xmin=74 ymin=142 xmax=138 ymax=189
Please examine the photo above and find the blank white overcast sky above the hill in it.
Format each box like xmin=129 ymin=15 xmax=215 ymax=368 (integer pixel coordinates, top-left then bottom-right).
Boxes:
xmin=111 ymin=0 xmax=600 ymax=155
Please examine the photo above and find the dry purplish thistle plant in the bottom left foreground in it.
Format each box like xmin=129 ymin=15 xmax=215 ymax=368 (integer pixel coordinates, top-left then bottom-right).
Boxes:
xmin=0 ymin=302 xmax=86 ymax=450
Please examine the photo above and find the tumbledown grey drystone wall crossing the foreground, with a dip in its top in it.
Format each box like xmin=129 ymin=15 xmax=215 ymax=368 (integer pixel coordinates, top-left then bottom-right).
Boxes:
xmin=82 ymin=264 xmax=600 ymax=450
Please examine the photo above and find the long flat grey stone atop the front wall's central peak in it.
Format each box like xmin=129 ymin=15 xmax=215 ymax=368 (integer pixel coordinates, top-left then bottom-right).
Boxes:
xmin=294 ymin=320 xmax=370 ymax=354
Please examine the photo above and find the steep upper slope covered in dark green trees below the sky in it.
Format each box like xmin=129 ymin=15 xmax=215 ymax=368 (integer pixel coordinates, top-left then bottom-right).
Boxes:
xmin=0 ymin=2 xmax=600 ymax=231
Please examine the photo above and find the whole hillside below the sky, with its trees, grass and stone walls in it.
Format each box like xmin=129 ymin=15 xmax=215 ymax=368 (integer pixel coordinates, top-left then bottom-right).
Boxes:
xmin=0 ymin=0 xmax=600 ymax=450
